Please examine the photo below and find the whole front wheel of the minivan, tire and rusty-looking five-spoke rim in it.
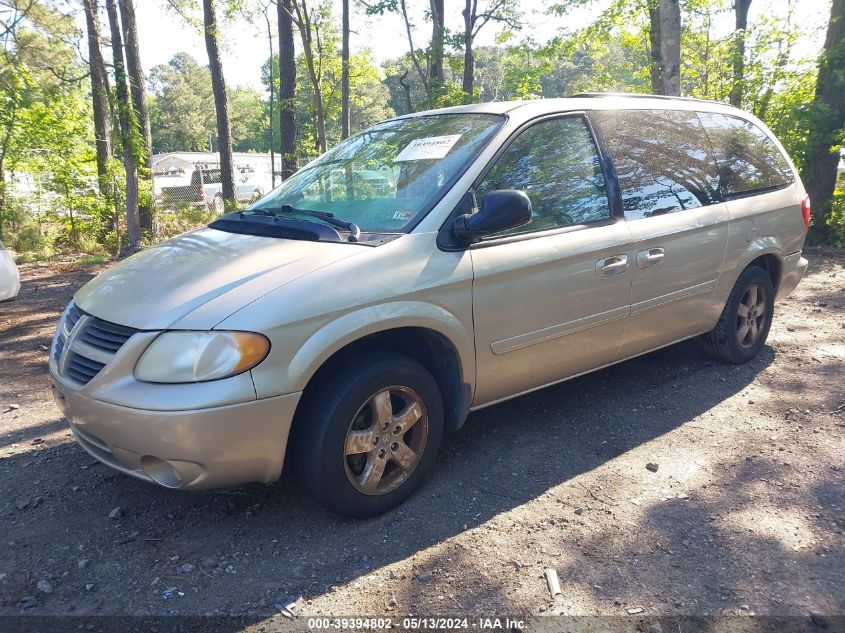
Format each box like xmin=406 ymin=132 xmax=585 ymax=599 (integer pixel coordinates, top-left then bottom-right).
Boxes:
xmin=289 ymin=352 xmax=443 ymax=518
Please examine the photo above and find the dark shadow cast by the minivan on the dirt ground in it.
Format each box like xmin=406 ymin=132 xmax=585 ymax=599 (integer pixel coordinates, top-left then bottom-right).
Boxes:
xmin=0 ymin=342 xmax=774 ymax=616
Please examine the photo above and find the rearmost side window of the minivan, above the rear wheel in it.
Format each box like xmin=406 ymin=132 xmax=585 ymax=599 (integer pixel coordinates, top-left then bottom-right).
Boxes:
xmin=698 ymin=112 xmax=795 ymax=196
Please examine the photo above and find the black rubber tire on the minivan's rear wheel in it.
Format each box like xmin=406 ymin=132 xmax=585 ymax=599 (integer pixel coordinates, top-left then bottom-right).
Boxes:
xmin=701 ymin=266 xmax=775 ymax=363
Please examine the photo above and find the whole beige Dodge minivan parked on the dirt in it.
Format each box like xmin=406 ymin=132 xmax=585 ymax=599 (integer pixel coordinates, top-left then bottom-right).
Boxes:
xmin=50 ymin=95 xmax=810 ymax=517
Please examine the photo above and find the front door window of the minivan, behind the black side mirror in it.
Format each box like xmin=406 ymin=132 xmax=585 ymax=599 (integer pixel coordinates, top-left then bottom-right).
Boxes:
xmin=476 ymin=116 xmax=611 ymax=237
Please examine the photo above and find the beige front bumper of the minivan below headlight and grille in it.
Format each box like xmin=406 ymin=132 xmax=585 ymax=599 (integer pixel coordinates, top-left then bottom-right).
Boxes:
xmin=52 ymin=379 xmax=301 ymax=490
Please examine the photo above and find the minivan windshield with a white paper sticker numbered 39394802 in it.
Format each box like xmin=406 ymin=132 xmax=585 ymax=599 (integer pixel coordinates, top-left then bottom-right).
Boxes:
xmin=250 ymin=114 xmax=505 ymax=233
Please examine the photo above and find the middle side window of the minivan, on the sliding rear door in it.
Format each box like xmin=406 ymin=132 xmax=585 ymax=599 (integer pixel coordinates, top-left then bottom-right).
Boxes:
xmin=593 ymin=110 xmax=719 ymax=220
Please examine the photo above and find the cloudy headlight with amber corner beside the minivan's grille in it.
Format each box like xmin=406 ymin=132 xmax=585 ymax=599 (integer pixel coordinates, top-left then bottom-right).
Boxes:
xmin=135 ymin=332 xmax=270 ymax=382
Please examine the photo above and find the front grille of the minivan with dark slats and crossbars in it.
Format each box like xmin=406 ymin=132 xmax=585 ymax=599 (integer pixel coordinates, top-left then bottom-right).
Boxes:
xmin=52 ymin=302 xmax=138 ymax=385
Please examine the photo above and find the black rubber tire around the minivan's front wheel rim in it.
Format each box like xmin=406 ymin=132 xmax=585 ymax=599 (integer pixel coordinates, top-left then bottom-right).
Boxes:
xmin=287 ymin=351 xmax=444 ymax=519
